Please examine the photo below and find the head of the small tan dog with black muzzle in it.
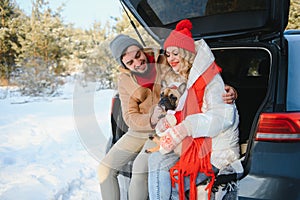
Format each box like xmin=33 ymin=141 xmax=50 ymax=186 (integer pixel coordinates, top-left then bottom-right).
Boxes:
xmin=158 ymin=81 xmax=186 ymax=111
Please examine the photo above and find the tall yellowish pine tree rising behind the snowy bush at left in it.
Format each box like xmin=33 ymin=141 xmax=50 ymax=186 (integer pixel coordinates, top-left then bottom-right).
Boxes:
xmin=19 ymin=0 xmax=68 ymax=73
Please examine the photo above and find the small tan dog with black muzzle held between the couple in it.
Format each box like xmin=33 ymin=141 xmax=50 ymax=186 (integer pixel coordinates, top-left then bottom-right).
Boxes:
xmin=145 ymin=80 xmax=186 ymax=153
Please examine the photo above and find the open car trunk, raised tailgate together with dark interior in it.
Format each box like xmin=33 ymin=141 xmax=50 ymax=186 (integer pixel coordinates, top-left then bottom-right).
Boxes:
xmin=121 ymin=0 xmax=290 ymax=159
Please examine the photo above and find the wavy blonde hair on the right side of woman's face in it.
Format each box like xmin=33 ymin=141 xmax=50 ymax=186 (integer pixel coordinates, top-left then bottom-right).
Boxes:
xmin=178 ymin=48 xmax=196 ymax=79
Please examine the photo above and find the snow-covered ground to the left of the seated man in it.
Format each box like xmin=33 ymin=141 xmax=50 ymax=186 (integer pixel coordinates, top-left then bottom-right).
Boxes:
xmin=0 ymin=79 xmax=113 ymax=200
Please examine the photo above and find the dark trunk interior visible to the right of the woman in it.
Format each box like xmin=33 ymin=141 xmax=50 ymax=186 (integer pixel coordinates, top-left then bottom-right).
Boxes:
xmin=212 ymin=47 xmax=272 ymax=154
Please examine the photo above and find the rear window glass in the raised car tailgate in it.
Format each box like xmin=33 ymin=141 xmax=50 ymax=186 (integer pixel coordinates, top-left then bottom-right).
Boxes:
xmin=138 ymin=0 xmax=268 ymax=25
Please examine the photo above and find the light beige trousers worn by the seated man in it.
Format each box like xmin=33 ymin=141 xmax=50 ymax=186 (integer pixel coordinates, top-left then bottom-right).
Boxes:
xmin=98 ymin=133 xmax=156 ymax=200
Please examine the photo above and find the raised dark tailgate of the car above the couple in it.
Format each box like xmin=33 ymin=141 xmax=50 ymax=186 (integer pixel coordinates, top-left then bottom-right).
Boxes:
xmin=121 ymin=0 xmax=290 ymax=41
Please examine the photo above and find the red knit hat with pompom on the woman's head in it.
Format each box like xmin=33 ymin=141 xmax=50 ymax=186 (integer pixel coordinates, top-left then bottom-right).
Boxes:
xmin=164 ymin=19 xmax=196 ymax=53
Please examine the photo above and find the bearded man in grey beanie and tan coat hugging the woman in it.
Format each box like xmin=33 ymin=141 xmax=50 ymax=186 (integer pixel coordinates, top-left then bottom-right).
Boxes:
xmin=98 ymin=34 xmax=236 ymax=200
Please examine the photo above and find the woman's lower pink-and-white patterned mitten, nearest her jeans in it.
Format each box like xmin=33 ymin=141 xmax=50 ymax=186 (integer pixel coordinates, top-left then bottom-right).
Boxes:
xmin=159 ymin=123 xmax=188 ymax=154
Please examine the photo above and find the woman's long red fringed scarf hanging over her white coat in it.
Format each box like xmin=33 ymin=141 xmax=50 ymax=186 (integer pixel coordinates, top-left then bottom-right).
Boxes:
xmin=170 ymin=62 xmax=221 ymax=200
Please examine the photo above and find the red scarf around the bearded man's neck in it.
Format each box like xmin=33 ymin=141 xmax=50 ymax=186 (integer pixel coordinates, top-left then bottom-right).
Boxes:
xmin=135 ymin=54 xmax=156 ymax=90
